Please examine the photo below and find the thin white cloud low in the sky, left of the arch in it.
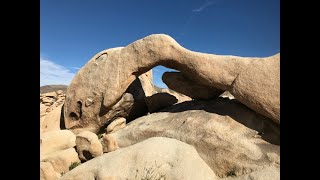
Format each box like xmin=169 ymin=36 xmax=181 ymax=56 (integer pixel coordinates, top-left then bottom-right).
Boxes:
xmin=40 ymin=58 xmax=75 ymax=86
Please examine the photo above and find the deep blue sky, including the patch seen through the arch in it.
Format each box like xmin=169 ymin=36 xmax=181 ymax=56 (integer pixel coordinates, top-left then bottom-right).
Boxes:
xmin=40 ymin=0 xmax=280 ymax=87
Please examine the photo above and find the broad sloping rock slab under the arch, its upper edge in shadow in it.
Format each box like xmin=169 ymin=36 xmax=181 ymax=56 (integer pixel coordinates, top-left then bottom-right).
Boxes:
xmin=104 ymin=97 xmax=280 ymax=177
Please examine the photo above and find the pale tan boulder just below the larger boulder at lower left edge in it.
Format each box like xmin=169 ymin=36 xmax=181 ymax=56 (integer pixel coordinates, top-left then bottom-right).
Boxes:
xmin=43 ymin=148 xmax=80 ymax=174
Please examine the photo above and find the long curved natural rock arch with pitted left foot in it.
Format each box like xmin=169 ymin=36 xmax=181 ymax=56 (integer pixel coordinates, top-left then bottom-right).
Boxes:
xmin=64 ymin=34 xmax=280 ymax=132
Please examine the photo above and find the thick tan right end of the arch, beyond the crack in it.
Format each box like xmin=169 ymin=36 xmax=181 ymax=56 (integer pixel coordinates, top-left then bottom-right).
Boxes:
xmin=230 ymin=54 xmax=280 ymax=124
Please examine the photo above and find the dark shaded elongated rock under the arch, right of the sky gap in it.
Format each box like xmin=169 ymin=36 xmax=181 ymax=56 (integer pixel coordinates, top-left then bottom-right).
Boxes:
xmin=162 ymin=72 xmax=223 ymax=99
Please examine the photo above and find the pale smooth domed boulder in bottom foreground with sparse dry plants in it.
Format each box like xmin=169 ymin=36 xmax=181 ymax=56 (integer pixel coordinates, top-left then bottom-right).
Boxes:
xmin=61 ymin=137 xmax=217 ymax=180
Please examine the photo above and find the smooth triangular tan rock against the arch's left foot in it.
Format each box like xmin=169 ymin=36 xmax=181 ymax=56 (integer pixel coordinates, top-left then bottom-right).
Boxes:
xmin=40 ymin=105 xmax=62 ymax=132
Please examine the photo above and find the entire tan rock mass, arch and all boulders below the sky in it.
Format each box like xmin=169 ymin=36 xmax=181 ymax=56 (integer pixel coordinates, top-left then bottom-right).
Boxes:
xmin=40 ymin=34 xmax=280 ymax=180
